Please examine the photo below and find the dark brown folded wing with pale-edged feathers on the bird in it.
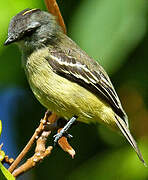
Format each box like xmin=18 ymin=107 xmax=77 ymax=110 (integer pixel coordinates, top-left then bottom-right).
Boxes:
xmin=46 ymin=51 xmax=128 ymax=126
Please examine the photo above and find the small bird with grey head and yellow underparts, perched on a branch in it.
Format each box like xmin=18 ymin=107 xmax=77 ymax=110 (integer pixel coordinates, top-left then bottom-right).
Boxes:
xmin=4 ymin=8 xmax=146 ymax=165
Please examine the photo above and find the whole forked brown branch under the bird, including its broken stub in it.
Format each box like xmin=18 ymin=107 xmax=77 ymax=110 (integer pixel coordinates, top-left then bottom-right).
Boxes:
xmin=9 ymin=111 xmax=75 ymax=177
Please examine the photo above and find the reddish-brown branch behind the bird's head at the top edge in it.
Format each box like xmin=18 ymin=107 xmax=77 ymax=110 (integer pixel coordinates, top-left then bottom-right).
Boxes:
xmin=45 ymin=0 xmax=66 ymax=34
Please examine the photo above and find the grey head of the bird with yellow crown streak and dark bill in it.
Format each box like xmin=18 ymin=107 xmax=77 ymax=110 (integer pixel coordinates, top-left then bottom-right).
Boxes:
xmin=5 ymin=9 xmax=62 ymax=51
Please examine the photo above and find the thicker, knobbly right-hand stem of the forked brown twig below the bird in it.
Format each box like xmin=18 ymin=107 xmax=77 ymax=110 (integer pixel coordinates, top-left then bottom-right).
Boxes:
xmin=12 ymin=111 xmax=58 ymax=177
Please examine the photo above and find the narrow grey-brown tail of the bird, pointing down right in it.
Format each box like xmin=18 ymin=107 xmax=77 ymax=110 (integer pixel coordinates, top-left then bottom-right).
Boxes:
xmin=115 ymin=115 xmax=147 ymax=166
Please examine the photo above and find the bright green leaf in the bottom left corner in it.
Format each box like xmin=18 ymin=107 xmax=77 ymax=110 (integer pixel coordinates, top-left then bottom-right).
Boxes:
xmin=0 ymin=162 xmax=15 ymax=180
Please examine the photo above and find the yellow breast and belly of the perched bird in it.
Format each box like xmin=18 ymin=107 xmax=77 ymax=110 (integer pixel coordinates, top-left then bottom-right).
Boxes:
xmin=25 ymin=47 xmax=114 ymax=125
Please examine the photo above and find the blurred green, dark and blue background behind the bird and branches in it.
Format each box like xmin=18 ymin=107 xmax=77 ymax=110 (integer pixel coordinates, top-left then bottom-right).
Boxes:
xmin=0 ymin=0 xmax=148 ymax=180
